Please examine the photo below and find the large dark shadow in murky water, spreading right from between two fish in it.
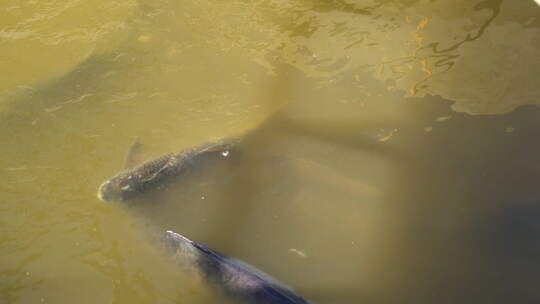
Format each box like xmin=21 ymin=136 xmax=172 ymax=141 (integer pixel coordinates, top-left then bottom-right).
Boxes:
xmin=109 ymin=93 xmax=540 ymax=303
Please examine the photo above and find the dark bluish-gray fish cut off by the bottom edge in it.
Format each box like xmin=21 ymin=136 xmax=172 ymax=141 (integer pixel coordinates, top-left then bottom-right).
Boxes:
xmin=166 ymin=231 xmax=309 ymax=304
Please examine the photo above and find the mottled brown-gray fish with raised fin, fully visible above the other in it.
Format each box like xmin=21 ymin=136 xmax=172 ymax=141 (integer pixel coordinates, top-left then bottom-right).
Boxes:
xmin=97 ymin=140 xmax=238 ymax=201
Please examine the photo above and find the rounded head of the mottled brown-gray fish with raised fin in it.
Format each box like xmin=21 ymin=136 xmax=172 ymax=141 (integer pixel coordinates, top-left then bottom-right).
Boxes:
xmin=97 ymin=174 xmax=138 ymax=202
